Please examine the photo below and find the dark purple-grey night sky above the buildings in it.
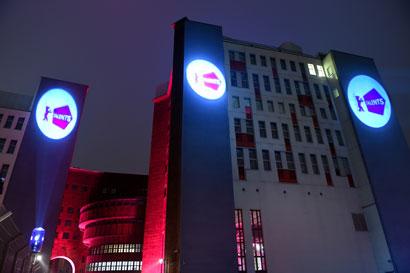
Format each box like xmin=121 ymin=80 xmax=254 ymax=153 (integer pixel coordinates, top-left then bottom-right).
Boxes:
xmin=0 ymin=0 xmax=410 ymax=173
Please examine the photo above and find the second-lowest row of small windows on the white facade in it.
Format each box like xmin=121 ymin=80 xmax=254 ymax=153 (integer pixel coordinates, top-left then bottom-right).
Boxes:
xmin=234 ymin=118 xmax=345 ymax=146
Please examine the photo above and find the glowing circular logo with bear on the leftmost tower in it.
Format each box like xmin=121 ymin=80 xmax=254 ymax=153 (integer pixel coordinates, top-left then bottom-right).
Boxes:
xmin=35 ymin=88 xmax=78 ymax=139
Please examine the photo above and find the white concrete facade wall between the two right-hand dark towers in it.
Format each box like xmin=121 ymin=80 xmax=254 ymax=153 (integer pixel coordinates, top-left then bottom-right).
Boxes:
xmin=224 ymin=38 xmax=391 ymax=273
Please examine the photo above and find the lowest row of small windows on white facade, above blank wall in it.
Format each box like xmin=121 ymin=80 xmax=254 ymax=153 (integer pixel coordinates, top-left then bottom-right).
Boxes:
xmin=236 ymin=148 xmax=351 ymax=176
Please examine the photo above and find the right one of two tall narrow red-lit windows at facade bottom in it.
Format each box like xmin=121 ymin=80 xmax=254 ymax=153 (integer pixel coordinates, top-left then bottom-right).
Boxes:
xmin=251 ymin=210 xmax=266 ymax=272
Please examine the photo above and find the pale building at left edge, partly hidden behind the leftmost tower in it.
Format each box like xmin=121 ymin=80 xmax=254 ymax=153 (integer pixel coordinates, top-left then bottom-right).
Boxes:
xmin=0 ymin=91 xmax=33 ymax=205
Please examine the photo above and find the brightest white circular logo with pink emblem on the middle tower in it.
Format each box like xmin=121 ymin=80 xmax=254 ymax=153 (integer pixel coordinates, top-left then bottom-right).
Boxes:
xmin=186 ymin=60 xmax=226 ymax=100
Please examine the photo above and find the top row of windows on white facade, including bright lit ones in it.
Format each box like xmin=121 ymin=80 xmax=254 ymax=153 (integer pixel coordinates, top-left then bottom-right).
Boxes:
xmin=229 ymin=50 xmax=325 ymax=77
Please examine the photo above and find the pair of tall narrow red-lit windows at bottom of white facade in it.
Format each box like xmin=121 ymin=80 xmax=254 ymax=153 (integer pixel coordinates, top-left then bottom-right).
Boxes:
xmin=235 ymin=209 xmax=266 ymax=272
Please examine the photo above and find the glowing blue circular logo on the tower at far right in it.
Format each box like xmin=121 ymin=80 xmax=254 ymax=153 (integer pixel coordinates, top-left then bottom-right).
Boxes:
xmin=347 ymin=75 xmax=391 ymax=128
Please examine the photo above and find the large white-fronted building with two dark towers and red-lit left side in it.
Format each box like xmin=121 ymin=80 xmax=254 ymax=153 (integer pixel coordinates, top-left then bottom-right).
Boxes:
xmin=143 ymin=18 xmax=410 ymax=273
